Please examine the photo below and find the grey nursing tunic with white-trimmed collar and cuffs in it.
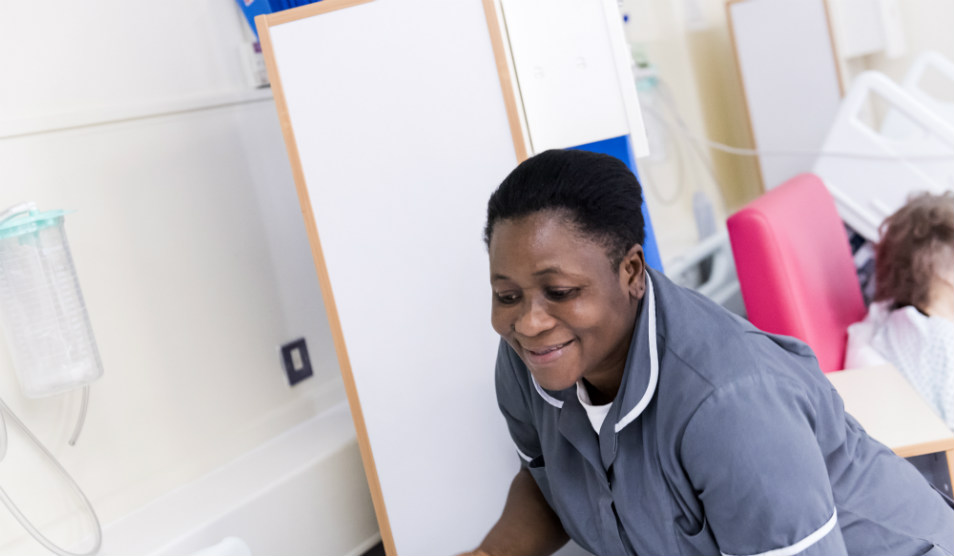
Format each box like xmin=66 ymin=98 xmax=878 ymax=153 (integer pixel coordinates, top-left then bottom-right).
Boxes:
xmin=496 ymin=270 xmax=954 ymax=556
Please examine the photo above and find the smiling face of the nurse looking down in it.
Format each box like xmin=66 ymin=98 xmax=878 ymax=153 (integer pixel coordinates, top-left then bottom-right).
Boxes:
xmin=489 ymin=212 xmax=645 ymax=396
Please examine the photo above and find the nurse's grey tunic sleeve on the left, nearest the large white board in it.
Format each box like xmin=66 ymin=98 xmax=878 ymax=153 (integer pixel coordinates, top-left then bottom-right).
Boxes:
xmin=496 ymin=341 xmax=543 ymax=467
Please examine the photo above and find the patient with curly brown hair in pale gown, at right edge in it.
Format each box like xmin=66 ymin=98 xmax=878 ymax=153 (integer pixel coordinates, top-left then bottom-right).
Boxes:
xmin=845 ymin=191 xmax=954 ymax=429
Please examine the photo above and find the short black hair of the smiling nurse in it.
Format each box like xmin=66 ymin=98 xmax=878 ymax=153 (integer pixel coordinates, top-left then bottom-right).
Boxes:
xmin=484 ymin=149 xmax=645 ymax=269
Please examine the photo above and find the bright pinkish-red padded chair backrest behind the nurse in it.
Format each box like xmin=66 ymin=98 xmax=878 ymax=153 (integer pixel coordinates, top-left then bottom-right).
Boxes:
xmin=727 ymin=174 xmax=866 ymax=372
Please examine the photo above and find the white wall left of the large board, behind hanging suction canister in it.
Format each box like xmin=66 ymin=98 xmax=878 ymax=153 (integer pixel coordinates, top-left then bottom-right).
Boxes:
xmin=0 ymin=0 xmax=371 ymax=554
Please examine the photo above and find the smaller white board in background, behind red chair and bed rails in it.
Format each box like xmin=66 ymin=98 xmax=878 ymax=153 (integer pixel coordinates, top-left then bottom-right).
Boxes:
xmin=729 ymin=0 xmax=841 ymax=189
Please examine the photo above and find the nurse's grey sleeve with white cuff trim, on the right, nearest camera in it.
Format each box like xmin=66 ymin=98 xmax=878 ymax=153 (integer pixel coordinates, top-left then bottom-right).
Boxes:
xmin=680 ymin=376 xmax=846 ymax=556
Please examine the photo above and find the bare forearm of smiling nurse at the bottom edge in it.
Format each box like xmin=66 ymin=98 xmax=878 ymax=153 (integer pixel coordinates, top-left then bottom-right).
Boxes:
xmin=471 ymin=467 xmax=570 ymax=556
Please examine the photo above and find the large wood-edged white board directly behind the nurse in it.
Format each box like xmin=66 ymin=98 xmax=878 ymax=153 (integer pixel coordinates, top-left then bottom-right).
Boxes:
xmin=270 ymin=0 xmax=518 ymax=555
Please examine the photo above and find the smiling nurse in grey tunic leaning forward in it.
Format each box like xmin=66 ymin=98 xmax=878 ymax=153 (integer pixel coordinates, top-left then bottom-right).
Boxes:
xmin=475 ymin=151 xmax=954 ymax=556
